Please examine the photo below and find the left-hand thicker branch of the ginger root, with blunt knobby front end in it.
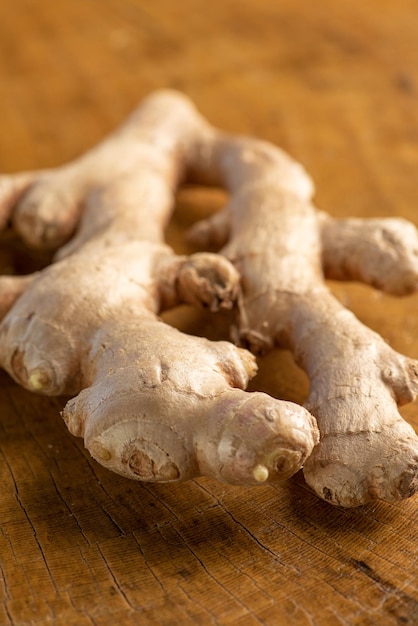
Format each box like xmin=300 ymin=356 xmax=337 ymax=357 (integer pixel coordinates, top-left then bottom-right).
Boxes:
xmin=0 ymin=92 xmax=318 ymax=485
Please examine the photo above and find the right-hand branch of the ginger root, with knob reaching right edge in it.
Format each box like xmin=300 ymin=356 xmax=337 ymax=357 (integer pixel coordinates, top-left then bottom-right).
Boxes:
xmin=190 ymin=105 xmax=418 ymax=507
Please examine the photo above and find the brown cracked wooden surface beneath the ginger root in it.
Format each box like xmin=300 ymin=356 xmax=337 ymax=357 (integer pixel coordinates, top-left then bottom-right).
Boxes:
xmin=0 ymin=0 xmax=418 ymax=626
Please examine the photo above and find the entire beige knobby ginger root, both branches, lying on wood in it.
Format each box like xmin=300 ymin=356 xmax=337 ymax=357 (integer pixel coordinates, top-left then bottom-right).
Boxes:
xmin=0 ymin=92 xmax=418 ymax=506
